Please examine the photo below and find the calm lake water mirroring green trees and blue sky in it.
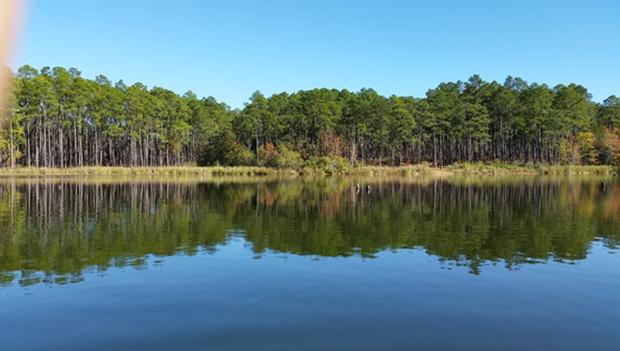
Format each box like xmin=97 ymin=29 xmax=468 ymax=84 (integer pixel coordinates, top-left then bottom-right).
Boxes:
xmin=0 ymin=177 xmax=620 ymax=351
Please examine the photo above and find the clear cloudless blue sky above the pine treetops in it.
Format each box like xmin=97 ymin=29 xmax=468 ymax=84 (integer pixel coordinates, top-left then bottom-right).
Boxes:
xmin=13 ymin=0 xmax=620 ymax=107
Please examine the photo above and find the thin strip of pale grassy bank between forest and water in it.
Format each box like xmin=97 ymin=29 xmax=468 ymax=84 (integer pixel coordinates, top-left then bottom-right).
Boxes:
xmin=0 ymin=163 xmax=620 ymax=177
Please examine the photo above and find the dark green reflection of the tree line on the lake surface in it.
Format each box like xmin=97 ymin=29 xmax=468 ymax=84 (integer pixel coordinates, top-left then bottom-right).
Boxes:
xmin=0 ymin=178 xmax=620 ymax=285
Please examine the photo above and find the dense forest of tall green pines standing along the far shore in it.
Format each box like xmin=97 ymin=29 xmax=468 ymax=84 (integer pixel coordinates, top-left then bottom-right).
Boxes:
xmin=0 ymin=65 xmax=620 ymax=168
